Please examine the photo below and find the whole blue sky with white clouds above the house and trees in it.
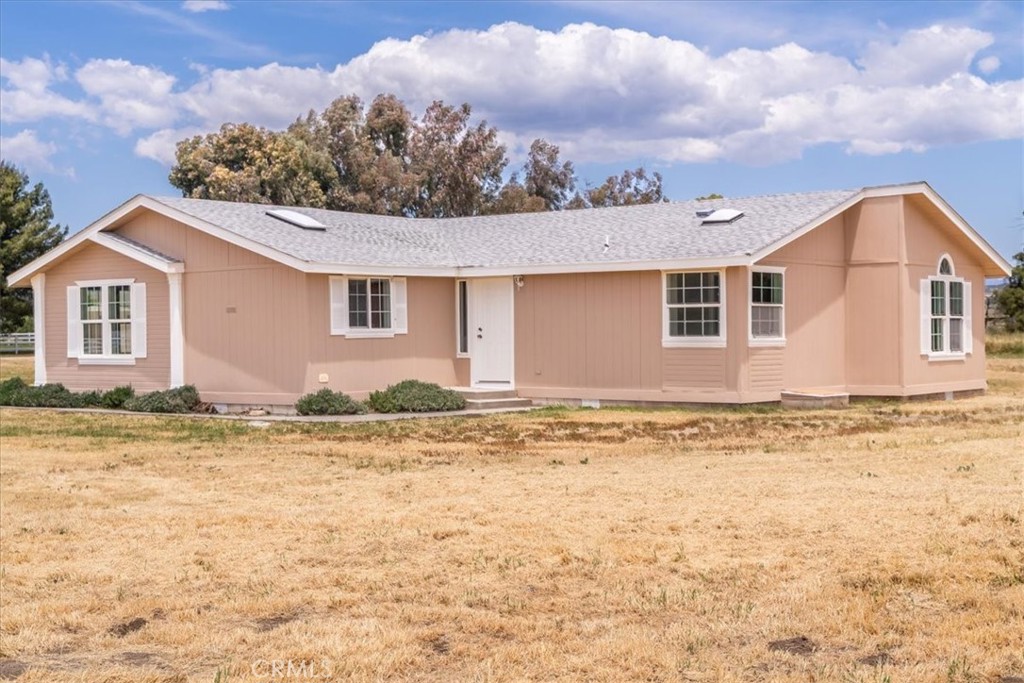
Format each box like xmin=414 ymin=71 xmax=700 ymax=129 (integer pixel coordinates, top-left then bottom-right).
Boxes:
xmin=0 ymin=0 xmax=1024 ymax=257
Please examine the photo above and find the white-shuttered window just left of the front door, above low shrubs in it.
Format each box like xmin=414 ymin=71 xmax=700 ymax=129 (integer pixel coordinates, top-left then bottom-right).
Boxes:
xmin=329 ymin=275 xmax=408 ymax=337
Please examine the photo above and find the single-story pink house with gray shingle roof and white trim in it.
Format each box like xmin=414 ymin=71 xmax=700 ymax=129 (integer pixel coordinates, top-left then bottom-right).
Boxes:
xmin=9 ymin=182 xmax=1010 ymax=407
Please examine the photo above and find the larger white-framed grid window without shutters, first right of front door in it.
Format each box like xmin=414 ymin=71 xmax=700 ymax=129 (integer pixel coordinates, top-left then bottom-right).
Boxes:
xmin=663 ymin=270 xmax=725 ymax=346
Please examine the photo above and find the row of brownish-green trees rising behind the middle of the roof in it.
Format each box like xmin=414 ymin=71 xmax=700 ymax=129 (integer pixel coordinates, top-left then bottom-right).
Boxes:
xmin=169 ymin=94 xmax=666 ymax=217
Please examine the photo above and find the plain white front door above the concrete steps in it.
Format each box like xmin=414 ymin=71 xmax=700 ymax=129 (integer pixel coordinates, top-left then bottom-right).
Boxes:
xmin=469 ymin=278 xmax=515 ymax=388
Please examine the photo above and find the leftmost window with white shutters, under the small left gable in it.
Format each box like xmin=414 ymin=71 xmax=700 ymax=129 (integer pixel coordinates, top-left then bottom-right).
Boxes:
xmin=68 ymin=280 xmax=145 ymax=364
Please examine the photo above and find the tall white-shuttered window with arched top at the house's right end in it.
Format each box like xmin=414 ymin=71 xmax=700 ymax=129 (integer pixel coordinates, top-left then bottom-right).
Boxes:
xmin=921 ymin=255 xmax=973 ymax=359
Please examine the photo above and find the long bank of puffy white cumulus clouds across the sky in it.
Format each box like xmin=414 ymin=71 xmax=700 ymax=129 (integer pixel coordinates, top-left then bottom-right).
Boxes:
xmin=0 ymin=23 xmax=1024 ymax=164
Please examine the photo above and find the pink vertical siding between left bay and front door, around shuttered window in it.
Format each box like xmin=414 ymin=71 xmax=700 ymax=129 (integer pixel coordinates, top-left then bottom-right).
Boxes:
xmin=119 ymin=213 xmax=460 ymax=404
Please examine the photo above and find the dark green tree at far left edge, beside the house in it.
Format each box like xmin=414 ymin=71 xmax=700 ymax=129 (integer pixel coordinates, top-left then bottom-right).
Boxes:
xmin=0 ymin=160 xmax=68 ymax=332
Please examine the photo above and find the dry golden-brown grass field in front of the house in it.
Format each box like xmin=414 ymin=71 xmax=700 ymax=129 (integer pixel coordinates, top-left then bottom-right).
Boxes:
xmin=0 ymin=359 xmax=1024 ymax=683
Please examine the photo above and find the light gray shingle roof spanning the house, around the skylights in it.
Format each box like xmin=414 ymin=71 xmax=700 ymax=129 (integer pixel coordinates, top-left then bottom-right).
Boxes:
xmin=151 ymin=189 xmax=860 ymax=267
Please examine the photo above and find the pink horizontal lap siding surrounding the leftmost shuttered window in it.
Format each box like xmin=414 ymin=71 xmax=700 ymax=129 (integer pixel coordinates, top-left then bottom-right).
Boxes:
xmin=45 ymin=244 xmax=171 ymax=391
